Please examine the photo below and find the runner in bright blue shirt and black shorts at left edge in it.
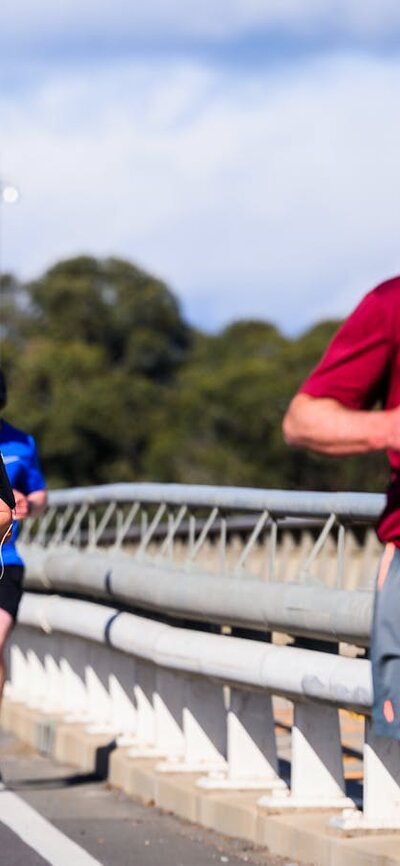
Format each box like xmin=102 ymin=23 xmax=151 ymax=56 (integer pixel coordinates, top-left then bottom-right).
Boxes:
xmin=0 ymin=370 xmax=47 ymax=699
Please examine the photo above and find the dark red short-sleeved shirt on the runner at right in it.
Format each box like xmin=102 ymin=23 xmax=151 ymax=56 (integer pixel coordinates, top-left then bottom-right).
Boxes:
xmin=300 ymin=277 xmax=400 ymax=547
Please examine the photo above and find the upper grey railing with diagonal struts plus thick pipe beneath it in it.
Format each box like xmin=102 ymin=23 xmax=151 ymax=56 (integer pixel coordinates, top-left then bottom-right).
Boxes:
xmin=21 ymin=484 xmax=383 ymax=646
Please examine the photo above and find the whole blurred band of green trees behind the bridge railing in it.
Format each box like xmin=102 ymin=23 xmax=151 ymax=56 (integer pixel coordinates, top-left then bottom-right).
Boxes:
xmin=0 ymin=256 xmax=387 ymax=491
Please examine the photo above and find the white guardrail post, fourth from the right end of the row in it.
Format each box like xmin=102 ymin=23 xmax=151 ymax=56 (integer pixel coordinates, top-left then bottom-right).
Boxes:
xmin=157 ymin=677 xmax=226 ymax=773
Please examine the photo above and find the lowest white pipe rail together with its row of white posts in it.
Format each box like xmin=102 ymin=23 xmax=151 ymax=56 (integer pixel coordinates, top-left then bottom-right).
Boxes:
xmin=7 ymin=593 xmax=400 ymax=830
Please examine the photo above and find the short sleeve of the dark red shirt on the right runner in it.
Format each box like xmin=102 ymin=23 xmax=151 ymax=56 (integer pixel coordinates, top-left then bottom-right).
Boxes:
xmin=300 ymin=289 xmax=393 ymax=409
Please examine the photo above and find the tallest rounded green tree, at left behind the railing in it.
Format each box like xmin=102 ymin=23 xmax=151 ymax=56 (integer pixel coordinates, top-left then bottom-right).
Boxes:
xmin=6 ymin=257 xmax=191 ymax=486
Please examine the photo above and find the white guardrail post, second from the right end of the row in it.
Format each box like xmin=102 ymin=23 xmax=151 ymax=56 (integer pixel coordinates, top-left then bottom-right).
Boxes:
xmin=258 ymin=703 xmax=355 ymax=809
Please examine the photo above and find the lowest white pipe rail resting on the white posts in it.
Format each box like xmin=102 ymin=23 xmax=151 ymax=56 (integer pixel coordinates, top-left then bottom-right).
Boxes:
xmin=19 ymin=593 xmax=372 ymax=714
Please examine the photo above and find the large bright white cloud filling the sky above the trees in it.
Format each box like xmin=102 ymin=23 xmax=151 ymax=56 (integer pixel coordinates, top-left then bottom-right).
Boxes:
xmin=0 ymin=57 xmax=400 ymax=330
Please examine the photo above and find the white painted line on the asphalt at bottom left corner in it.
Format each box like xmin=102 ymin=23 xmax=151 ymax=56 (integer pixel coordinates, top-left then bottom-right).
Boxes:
xmin=0 ymin=790 xmax=101 ymax=866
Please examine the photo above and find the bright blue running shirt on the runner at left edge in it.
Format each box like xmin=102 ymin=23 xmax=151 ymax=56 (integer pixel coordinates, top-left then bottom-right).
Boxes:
xmin=0 ymin=419 xmax=46 ymax=565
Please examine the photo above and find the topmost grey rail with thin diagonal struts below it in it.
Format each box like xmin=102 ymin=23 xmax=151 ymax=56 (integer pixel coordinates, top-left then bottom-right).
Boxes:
xmin=21 ymin=484 xmax=384 ymax=588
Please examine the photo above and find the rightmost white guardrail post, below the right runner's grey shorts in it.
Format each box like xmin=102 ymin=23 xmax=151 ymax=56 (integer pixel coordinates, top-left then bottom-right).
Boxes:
xmin=330 ymin=719 xmax=400 ymax=830
